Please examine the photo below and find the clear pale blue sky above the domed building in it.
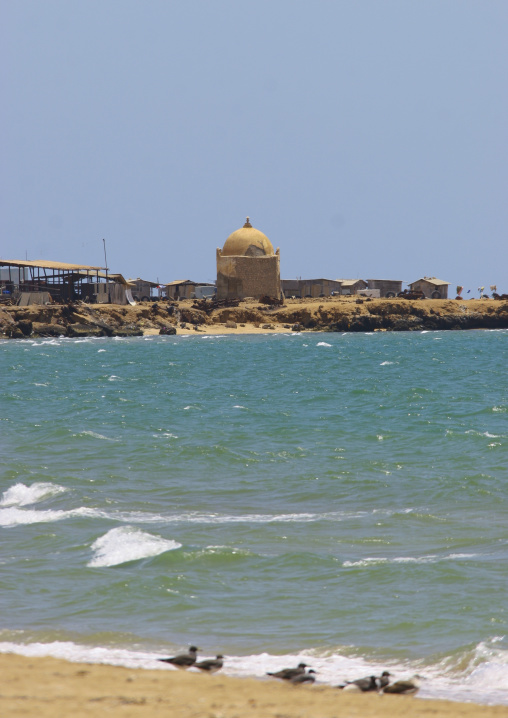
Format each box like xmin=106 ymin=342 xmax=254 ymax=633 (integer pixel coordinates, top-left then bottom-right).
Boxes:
xmin=0 ymin=0 xmax=508 ymax=296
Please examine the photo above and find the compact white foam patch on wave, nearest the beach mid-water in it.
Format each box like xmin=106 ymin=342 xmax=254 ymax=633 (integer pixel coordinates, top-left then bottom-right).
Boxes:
xmin=87 ymin=526 xmax=182 ymax=568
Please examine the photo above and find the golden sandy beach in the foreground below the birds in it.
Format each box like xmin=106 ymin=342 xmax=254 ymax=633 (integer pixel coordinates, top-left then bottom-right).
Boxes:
xmin=0 ymin=653 xmax=508 ymax=718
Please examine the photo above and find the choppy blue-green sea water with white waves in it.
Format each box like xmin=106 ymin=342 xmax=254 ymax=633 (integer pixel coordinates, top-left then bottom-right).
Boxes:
xmin=0 ymin=331 xmax=508 ymax=705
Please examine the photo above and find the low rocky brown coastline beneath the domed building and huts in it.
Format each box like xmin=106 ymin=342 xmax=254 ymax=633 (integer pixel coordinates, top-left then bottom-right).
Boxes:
xmin=0 ymin=297 xmax=508 ymax=339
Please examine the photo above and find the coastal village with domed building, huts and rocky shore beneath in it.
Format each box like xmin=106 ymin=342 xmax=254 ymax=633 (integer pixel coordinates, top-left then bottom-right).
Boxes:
xmin=0 ymin=217 xmax=508 ymax=338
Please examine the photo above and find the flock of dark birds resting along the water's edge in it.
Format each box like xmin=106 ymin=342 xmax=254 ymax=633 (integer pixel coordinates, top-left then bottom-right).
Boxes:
xmin=157 ymin=646 xmax=420 ymax=695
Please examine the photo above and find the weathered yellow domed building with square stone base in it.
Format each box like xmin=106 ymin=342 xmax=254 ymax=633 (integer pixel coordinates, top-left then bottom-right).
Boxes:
xmin=217 ymin=217 xmax=281 ymax=299
